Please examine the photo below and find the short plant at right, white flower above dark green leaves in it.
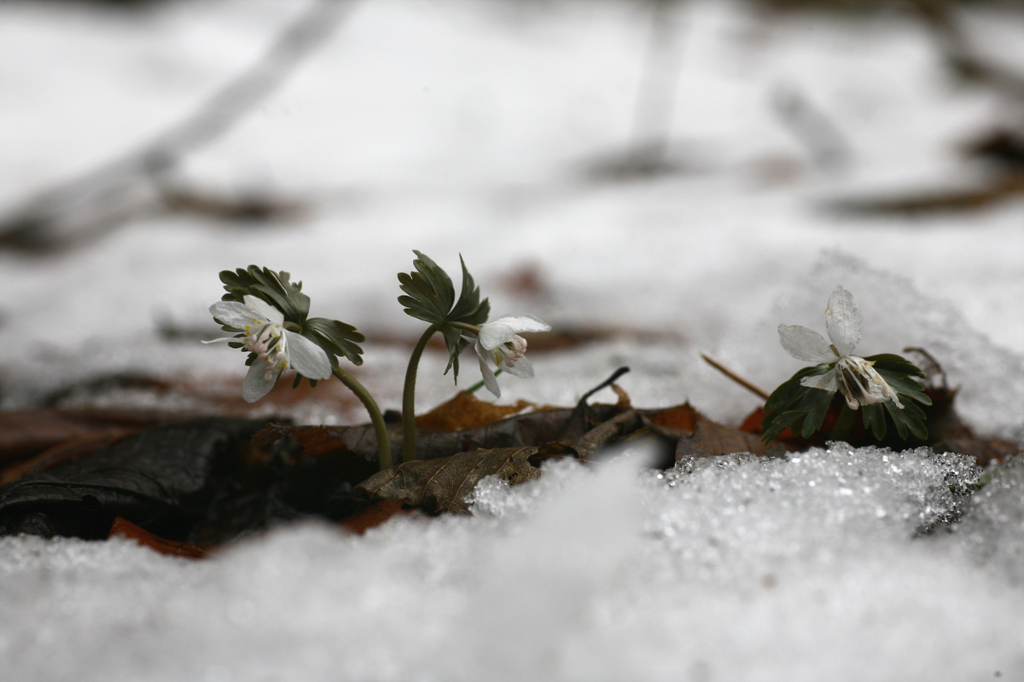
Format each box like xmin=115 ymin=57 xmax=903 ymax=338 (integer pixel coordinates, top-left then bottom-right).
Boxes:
xmin=761 ymin=287 xmax=932 ymax=441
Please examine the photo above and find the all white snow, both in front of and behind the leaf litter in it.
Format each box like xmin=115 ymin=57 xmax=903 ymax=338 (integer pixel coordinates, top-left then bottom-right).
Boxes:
xmin=0 ymin=0 xmax=1024 ymax=681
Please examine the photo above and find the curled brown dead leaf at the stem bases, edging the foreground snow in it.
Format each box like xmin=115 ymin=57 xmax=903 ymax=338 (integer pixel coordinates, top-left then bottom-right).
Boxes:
xmin=352 ymin=447 xmax=541 ymax=514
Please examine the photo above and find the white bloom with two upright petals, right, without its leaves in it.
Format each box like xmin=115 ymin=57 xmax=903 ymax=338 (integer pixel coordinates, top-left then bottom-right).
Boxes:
xmin=778 ymin=287 xmax=903 ymax=410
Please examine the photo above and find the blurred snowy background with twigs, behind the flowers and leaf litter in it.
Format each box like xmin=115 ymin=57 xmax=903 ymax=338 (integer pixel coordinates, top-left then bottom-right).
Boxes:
xmin=0 ymin=0 xmax=1024 ymax=423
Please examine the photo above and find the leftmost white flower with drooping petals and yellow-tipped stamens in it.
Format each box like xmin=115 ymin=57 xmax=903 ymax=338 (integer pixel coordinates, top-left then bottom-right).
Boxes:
xmin=204 ymin=296 xmax=331 ymax=402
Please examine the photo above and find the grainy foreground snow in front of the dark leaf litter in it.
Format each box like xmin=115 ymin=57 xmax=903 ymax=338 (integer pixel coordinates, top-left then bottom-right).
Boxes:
xmin=0 ymin=444 xmax=1024 ymax=680
